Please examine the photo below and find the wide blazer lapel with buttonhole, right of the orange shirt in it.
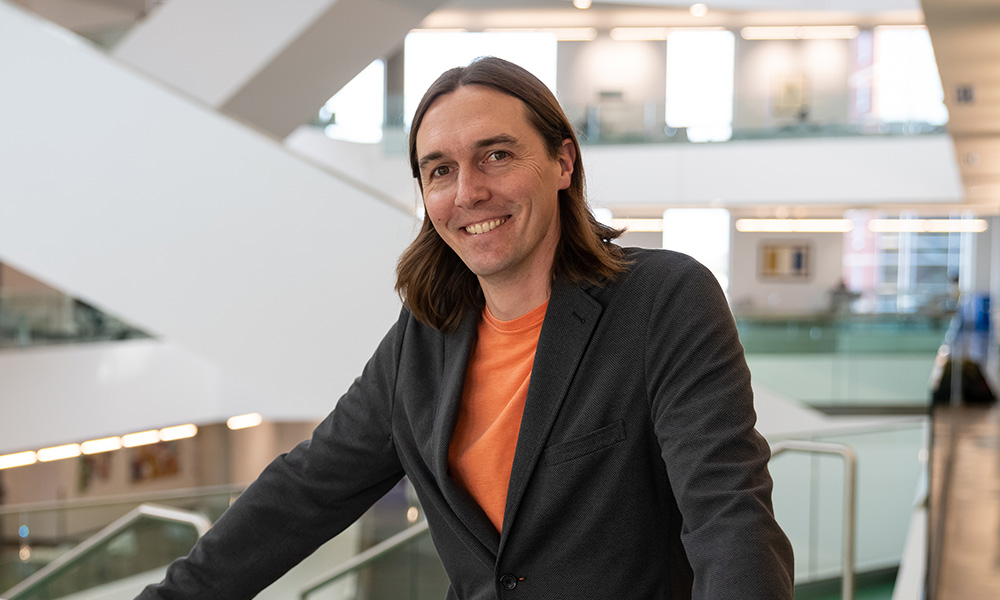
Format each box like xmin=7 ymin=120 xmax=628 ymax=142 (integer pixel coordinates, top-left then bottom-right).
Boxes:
xmin=500 ymin=280 xmax=603 ymax=551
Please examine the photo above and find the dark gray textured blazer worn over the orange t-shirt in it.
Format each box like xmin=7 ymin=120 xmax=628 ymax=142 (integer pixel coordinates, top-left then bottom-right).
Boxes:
xmin=140 ymin=250 xmax=792 ymax=600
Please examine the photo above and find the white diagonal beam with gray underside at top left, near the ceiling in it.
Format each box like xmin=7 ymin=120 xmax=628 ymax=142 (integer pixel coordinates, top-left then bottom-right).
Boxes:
xmin=114 ymin=0 xmax=443 ymax=138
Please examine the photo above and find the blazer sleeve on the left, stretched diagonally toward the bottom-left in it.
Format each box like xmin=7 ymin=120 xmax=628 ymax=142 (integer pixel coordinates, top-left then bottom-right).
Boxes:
xmin=138 ymin=311 xmax=407 ymax=600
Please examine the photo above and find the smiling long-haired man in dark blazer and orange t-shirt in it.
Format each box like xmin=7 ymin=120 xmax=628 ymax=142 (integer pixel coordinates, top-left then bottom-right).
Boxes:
xmin=140 ymin=58 xmax=792 ymax=600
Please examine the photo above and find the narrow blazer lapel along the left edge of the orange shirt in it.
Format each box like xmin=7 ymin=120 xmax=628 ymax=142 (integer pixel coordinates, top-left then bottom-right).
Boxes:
xmin=432 ymin=311 xmax=500 ymax=565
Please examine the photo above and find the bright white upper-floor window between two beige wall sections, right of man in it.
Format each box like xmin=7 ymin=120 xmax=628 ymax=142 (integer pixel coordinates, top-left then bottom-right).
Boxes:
xmin=666 ymin=31 xmax=736 ymax=142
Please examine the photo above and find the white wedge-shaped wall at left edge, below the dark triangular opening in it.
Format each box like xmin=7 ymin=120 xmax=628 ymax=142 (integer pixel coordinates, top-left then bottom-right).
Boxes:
xmin=0 ymin=339 xmax=280 ymax=454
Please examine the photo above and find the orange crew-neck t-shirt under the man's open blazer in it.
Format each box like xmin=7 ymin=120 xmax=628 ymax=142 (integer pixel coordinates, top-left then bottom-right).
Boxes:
xmin=448 ymin=301 xmax=549 ymax=531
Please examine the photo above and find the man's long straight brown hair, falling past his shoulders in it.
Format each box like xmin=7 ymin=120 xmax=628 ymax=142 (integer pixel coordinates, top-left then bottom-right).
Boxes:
xmin=396 ymin=57 xmax=625 ymax=332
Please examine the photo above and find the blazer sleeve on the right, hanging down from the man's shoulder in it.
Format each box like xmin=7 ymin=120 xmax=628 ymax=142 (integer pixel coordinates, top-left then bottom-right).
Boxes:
xmin=646 ymin=257 xmax=793 ymax=600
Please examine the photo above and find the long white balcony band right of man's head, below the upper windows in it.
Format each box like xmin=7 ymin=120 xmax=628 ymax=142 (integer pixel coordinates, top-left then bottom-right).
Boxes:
xmin=583 ymin=134 xmax=963 ymax=208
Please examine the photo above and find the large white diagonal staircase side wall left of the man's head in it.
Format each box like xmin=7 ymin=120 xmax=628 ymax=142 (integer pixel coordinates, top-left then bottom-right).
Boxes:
xmin=0 ymin=4 xmax=414 ymax=452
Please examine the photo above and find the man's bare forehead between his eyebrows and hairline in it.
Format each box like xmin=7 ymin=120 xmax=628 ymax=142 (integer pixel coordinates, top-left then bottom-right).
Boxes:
xmin=416 ymin=85 xmax=541 ymax=157
